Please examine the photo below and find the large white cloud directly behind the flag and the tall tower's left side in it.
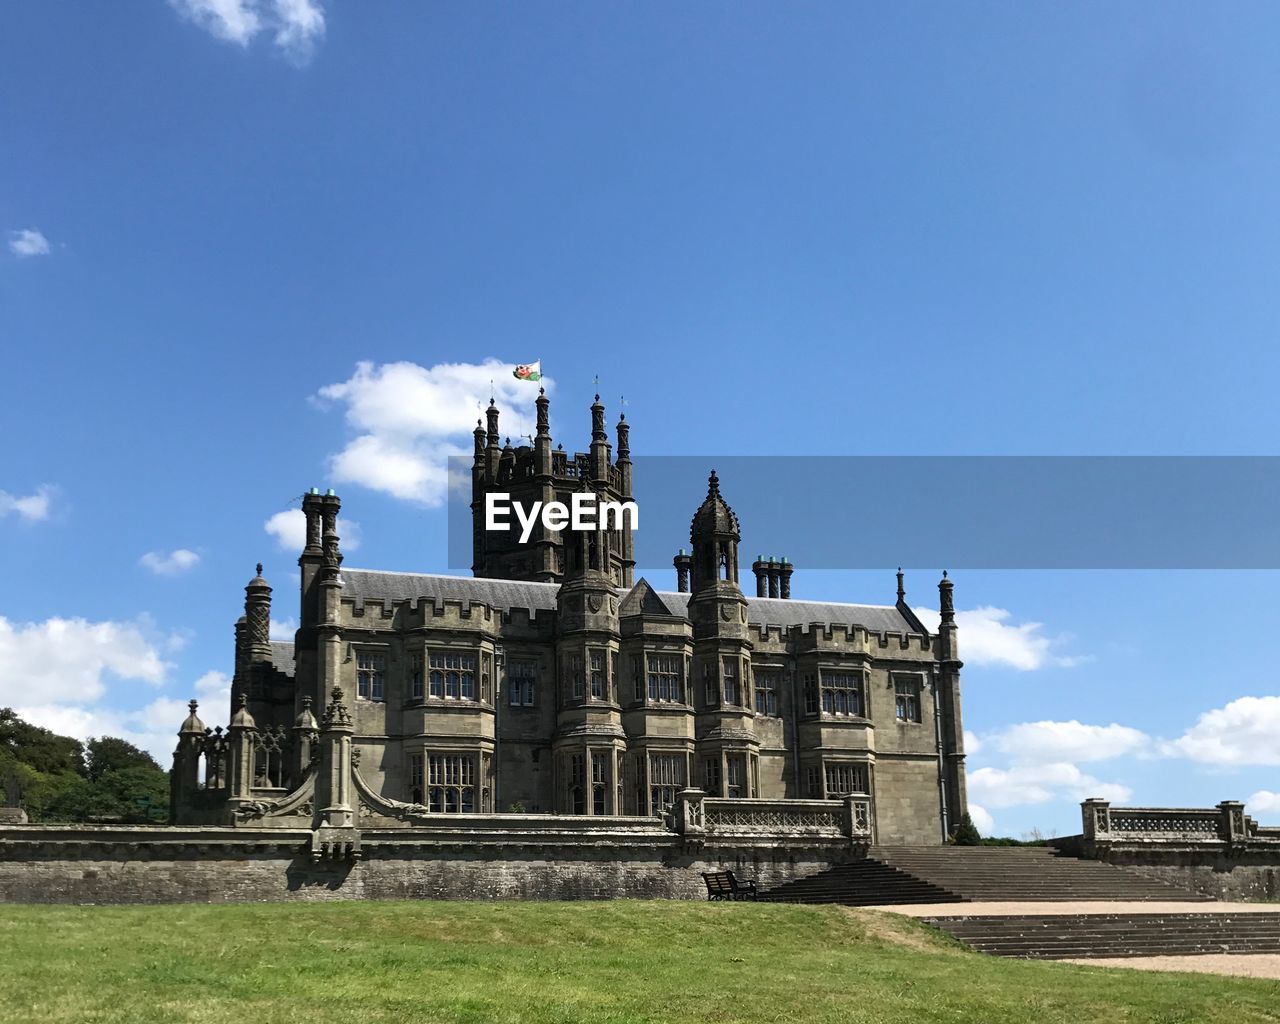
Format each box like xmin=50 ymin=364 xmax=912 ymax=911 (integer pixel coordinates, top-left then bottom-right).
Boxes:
xmin=316 ymin=358 xmax=553 ymax=507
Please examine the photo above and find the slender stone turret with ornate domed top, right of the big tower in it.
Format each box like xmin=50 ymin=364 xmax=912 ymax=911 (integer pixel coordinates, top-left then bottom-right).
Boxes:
xmin=689 ymin=470 xmax=760 ymax=796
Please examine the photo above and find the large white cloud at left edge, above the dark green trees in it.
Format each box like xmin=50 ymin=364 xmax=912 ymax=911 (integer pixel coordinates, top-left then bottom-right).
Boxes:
xmin=0 ymin=616 xmax=174 ymax=705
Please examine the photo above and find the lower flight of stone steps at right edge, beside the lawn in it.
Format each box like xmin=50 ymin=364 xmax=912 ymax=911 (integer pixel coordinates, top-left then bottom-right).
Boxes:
xmin=923 ymin=911 xmax=1280 ymax=960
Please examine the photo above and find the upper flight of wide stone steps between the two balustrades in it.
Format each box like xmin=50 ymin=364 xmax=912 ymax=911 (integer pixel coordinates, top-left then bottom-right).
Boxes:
xmin=760 ymin=846 xmax=1210 ymax=906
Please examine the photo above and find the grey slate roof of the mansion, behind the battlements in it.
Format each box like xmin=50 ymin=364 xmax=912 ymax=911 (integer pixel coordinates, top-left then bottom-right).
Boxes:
xmin=340 ymin=568 xmax=918 ymax=632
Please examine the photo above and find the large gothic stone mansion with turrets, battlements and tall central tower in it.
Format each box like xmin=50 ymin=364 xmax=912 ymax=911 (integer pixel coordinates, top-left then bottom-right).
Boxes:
xmin=172 ymin=394 xmax=965 ymax=844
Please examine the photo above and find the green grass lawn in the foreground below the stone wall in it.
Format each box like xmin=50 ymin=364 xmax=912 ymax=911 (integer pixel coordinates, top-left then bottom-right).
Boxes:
xmin=0 ymin=901 xmax=1280 ymax=1024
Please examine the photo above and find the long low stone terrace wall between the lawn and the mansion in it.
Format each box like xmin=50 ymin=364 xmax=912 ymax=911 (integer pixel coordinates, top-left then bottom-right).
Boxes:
xmin=0 ymin=826 xmax=861 ymax=904
